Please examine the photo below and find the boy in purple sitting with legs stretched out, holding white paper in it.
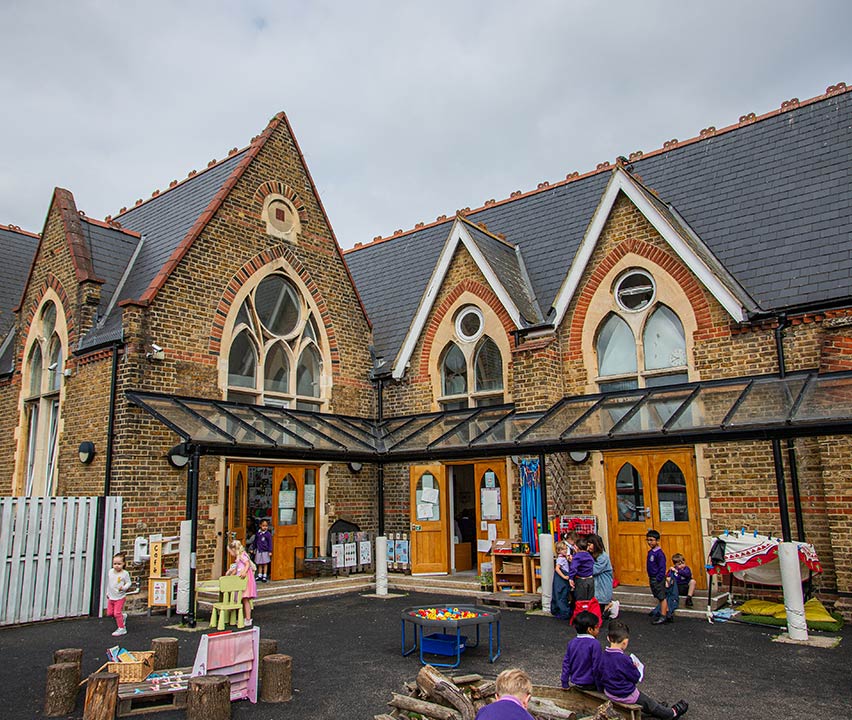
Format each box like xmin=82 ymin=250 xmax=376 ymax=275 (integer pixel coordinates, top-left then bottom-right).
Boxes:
xmin=596 ymin=620 xmax=689 ymax=720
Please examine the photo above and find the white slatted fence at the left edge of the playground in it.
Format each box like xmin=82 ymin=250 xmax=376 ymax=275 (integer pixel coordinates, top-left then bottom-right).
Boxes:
xmin=0 ymin=497 xmax=121 ymax=625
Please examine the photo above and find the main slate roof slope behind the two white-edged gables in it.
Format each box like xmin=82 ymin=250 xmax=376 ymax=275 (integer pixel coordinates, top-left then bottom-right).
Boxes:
xmin=346 ymin=86 xmax=852 ymax=368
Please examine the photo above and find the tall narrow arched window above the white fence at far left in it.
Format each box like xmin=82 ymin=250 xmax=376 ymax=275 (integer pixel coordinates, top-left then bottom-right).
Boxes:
xmin=19 ymin=297 xmax=68 ymax=497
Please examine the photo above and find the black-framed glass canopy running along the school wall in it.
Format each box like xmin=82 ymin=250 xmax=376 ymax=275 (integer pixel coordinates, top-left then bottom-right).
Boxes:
xmin=127 ymin=372 xmax=852 ymax=462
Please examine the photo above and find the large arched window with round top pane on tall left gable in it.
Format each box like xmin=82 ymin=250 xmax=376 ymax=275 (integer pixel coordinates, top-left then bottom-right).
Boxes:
xmin=223 ymin=268 xmax=330 ymax=412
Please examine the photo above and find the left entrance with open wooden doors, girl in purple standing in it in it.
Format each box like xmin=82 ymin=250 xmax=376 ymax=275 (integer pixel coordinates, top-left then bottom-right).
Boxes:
xmin=223 ymin=462 xmax=320 ymax=580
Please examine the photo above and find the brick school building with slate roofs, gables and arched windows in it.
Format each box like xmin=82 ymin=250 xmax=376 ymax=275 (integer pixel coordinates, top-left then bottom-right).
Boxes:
xmin=0 ymin=84 xmax=852 ymax=607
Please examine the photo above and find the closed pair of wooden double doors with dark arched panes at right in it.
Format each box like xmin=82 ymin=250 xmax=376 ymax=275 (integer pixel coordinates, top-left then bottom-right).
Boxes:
xmin=604 ymin=448 xmax=707 ymax=588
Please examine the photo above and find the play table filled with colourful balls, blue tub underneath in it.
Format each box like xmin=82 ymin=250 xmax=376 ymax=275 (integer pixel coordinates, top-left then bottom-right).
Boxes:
xmin=401 ymin=605 xmax=500 ymax=668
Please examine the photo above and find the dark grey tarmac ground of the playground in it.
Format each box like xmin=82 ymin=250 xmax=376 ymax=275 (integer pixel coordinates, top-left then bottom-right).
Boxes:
xmin=0 ymin=593 xmax=852 ymax=720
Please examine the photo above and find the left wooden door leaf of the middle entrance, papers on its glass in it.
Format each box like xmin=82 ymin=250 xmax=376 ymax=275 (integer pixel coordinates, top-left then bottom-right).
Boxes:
xmin=410 ymin=465 xmax=450 ymax=574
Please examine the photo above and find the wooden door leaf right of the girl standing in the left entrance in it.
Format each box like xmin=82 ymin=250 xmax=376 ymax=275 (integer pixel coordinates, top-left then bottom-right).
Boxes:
xmin=272 ymin=466 xmax=305 ymax=580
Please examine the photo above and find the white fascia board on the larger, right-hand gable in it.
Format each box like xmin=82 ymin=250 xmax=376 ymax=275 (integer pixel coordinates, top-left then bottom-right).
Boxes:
xmin=554 ymin=168 xmax=746 ymax=327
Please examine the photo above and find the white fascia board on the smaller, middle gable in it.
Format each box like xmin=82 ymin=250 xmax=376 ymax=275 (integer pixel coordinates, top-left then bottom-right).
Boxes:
xmin=391 ymin=220 xmax=521 ymax=380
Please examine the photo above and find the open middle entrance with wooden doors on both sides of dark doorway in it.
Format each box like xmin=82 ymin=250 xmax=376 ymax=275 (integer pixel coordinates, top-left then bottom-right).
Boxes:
xmin=409 ymin=458 xmax=509 ymax=574
